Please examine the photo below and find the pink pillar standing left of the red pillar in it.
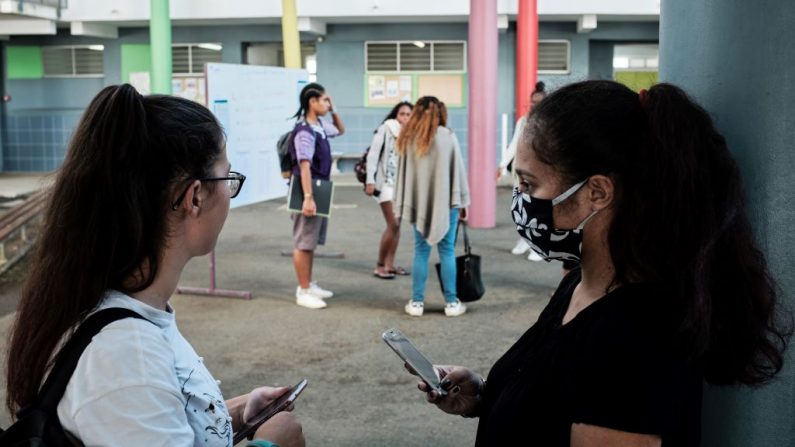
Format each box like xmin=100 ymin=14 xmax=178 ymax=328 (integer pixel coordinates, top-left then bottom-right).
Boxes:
xmin=467 ymin=0 xmax=497 ymax=228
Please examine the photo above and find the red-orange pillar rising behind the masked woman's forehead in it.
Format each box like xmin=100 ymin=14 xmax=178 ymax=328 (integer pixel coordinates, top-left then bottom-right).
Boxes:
xmin=515 ymin=0 xmax=538 ymax=120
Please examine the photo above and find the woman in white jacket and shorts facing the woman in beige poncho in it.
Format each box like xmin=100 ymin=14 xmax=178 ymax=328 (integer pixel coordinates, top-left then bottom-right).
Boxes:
xmin=365 ymin=101 xmax=414 ymax=279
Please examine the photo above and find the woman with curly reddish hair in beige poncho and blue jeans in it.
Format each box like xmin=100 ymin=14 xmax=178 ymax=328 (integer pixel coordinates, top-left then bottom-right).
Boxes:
xmin=395 ymin=96 xmax=469 ymax=317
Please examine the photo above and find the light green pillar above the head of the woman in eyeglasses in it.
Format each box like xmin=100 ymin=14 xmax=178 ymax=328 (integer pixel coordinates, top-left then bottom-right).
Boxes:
xmin=149 ymin=0 xmax=171 ymax=95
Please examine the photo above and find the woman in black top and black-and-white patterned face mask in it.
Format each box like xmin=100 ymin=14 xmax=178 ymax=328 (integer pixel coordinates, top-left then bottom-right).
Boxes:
xmin=404 ymin=81 xmax=792 ymax=446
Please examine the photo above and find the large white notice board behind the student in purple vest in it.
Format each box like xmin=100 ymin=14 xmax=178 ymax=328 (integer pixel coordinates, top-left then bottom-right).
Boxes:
xmin=206 ymin=63 xmax=309 ymax=207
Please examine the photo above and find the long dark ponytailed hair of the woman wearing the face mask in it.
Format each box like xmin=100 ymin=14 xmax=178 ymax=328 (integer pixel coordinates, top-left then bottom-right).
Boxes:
xmin=525 ymin=81 xmax=792 ymax=385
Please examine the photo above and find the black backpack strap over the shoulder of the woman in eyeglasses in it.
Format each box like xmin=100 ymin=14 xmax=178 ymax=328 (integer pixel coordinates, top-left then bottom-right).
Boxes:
xmin=25 ymin=307 xmax=149 ymax=414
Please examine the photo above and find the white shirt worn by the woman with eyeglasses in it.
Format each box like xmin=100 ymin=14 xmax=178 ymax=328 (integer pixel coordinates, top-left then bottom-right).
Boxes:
xmin=58 ymin=291 xmax=232 ymax=447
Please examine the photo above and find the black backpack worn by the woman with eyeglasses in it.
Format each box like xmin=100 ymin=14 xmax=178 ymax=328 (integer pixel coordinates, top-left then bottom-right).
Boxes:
xmin=0 ymin=308 xmax=145 ymax=447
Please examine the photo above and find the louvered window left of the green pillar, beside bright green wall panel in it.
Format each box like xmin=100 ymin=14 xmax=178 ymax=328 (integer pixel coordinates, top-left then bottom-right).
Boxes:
xmin=41 ymin=45 xmax=105 ymax=77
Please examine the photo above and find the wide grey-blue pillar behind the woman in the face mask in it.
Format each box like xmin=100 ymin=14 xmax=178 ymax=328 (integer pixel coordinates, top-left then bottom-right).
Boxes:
xmin=660 ymin=0 xmax=795 ymax=447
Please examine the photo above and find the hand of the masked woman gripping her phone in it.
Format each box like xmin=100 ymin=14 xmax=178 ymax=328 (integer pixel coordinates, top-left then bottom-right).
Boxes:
xmin=414 ymin=365 xmax=484 ymax=415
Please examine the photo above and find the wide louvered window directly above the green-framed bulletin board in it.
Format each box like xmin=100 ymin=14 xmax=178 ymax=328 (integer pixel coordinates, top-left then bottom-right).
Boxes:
xmin=365 ymin=41 xmax=466 ymax=73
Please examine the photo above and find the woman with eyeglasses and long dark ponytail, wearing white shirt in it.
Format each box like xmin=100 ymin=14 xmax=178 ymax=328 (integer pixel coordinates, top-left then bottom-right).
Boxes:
xmin=6 ymin=84 xmax=304 ymax=447
